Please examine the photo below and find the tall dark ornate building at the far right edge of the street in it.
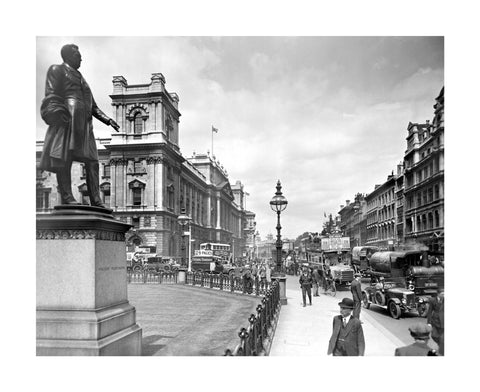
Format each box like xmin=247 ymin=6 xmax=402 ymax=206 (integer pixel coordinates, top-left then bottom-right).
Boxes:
xmin=404 ymin=88 xmax=445 ymax=255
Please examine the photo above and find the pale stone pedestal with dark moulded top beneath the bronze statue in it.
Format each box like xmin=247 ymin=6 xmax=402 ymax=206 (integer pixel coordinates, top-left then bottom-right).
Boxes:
xmin=36 ymin=206 xmax=142 ymax=356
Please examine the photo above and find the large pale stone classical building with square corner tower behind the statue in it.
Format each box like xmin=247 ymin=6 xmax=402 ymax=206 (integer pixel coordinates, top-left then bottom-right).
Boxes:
xmin=37 ymin=73 xmax=253 ymax=259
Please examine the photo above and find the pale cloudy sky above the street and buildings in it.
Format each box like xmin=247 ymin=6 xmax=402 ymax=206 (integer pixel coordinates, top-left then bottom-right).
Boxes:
xmin=36 ymin=36 xmax=444 ymax=238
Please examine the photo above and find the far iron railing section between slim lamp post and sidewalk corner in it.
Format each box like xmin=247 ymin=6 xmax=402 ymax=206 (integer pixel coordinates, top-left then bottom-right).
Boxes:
xmin=185 ymin=271 xmax=272 ymax=296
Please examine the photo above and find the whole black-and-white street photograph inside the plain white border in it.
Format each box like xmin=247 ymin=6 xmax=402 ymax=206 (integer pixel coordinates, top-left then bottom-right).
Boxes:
xmin=36 ymin=36 xmax=448 ymax=356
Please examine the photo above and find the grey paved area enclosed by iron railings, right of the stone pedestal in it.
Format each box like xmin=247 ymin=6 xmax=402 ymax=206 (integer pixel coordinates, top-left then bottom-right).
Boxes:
xmin=128 ymin=284 xmax=261 ymax=356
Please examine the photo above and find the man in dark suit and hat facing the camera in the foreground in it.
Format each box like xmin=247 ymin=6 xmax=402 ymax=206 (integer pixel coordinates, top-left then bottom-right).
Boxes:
xmin=327 ymin=298 xmax=365 ymax=357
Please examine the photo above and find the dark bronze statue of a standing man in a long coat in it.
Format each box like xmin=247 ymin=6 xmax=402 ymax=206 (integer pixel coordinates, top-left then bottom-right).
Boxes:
xmin=39 ymin=44 xmax=120 ymax=208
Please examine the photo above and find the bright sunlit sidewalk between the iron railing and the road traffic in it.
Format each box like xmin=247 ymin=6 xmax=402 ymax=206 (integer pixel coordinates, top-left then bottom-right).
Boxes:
xmin=269 ymin=288 xmax=405 ymax=356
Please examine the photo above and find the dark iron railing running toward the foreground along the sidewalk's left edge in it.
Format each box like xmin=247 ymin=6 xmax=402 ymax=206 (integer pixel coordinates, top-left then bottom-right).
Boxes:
xmin=225 ymin=280 xmax=281 ymax=356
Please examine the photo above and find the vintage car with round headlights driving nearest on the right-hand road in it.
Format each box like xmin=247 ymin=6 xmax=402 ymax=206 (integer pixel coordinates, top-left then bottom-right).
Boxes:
xmin=362 ymin=278 xmax=417 ymax=319
